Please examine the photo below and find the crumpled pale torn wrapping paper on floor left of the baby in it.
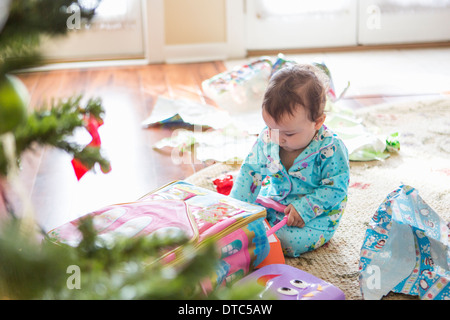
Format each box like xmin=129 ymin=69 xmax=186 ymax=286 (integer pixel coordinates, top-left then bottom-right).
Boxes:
xmin=142 ymin=96 xmax=264 ymax=163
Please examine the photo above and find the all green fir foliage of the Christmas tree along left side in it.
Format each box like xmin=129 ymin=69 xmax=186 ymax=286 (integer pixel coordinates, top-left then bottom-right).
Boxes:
xmin=0 ymin=0 xmax=256 ymax=300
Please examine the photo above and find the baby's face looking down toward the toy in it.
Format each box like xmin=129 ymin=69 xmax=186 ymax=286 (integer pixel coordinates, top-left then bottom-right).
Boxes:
xmin=262 ymin=105 xmax=325 ymax=152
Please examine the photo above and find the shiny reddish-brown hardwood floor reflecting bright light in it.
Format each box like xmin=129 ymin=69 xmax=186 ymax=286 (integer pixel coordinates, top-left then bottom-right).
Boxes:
xmin=2 ymin=57 xmax=446 ymax=231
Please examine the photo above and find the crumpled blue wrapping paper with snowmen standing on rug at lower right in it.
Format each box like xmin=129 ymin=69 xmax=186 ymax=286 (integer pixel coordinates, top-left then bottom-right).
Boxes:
xmin=359 ymin=185 xmax=450 ymax=300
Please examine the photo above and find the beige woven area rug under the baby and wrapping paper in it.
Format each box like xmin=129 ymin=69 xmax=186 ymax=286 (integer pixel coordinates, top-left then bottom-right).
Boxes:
xmin=187 ymin=99 xmax=450 ymax=300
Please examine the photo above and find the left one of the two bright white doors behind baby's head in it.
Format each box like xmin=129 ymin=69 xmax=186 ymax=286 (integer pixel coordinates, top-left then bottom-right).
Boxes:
xmin=245 ymin=0 xmax=358 ymax=50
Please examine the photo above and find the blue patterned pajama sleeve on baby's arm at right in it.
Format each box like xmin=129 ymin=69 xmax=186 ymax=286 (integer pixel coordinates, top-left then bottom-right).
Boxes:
xmin=291 ymin=140 xmax=350 ymax=224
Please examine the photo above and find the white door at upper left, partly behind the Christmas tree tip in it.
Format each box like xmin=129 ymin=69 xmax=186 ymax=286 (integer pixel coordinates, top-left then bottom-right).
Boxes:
xmin=42 ymin=0 xmax=145 ymax=61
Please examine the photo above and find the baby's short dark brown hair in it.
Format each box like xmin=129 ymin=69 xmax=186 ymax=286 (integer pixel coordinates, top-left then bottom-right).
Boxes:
xmin=262 ymin=64 xmax=329 ymax=122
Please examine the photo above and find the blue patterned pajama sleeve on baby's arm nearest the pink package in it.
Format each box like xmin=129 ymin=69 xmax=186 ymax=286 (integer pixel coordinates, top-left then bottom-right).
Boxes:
xmin=230 ymin=137 xmax=265 ymax=203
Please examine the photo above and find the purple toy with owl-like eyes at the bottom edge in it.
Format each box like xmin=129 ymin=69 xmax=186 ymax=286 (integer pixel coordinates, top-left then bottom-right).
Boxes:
xmin=235 ymin=264 xmax=345 ymax=300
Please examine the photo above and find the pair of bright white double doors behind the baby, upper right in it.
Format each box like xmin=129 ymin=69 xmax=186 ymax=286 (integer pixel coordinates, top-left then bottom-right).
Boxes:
xmin=245 ymin=0 xmax=450 ymax=50
